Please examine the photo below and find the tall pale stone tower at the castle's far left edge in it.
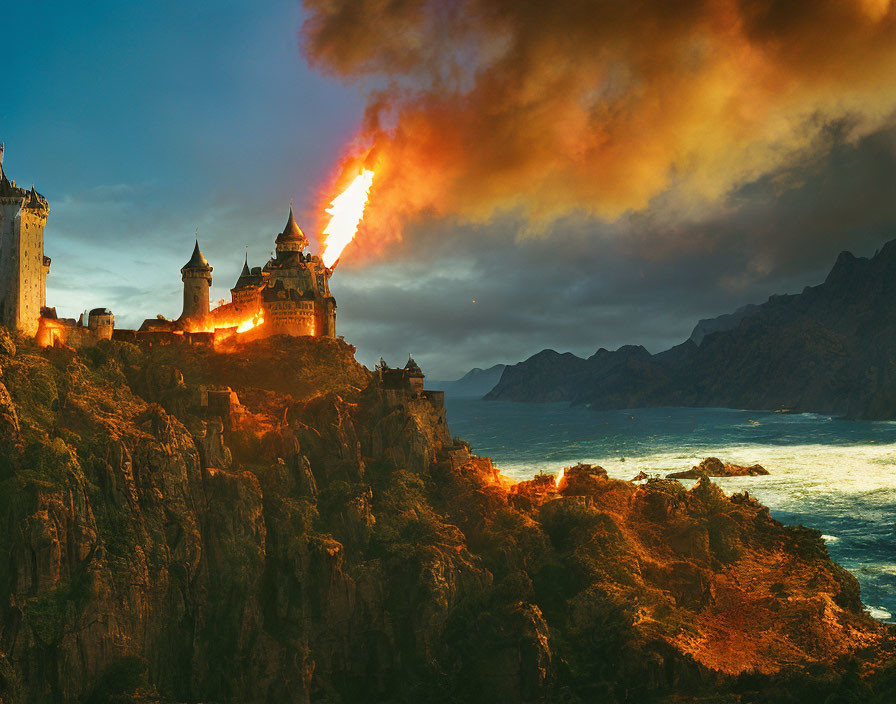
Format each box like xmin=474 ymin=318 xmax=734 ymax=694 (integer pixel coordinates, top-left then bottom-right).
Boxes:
xmin=0 ymin=145 xmax=50 ymax=336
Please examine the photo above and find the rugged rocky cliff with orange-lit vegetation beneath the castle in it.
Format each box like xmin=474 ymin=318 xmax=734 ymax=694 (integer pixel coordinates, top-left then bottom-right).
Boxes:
xmin=0 ymin=331 xmax=893 ymax=704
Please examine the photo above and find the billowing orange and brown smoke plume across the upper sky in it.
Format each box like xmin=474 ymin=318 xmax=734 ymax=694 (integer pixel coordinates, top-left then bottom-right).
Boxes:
xmin=302 ymin=0 xmax=896 ymax=248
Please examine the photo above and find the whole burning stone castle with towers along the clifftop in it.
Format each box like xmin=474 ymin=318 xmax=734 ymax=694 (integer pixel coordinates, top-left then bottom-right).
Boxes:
xmin=0 ymin=144 xmax=336 ymax=347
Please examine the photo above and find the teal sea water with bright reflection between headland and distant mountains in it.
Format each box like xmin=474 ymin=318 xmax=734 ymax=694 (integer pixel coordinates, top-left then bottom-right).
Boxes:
xmin=447 ymin=397 xmax=896 ymax=621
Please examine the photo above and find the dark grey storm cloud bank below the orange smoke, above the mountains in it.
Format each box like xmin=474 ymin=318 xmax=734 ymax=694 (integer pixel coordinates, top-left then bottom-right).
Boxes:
xmin=333 ymin=124 xmax=896 ymax=378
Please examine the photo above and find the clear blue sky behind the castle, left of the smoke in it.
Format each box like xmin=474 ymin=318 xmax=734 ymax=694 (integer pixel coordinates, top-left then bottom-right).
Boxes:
xmin=0 ymin=2 xmax=362 ymax=325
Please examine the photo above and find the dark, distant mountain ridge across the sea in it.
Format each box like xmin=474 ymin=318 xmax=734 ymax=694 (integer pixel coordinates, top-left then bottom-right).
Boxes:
xmin=486 ymin=241 xmax=896 ymax=419
